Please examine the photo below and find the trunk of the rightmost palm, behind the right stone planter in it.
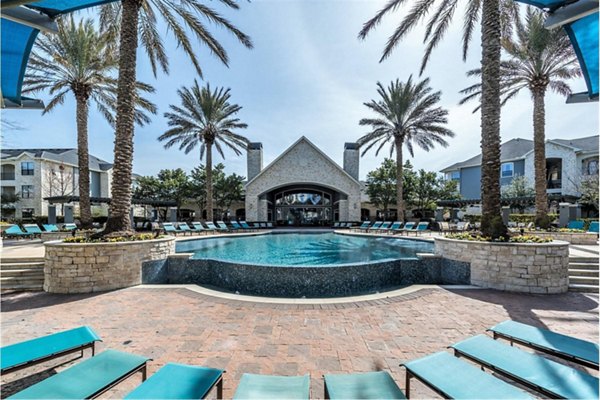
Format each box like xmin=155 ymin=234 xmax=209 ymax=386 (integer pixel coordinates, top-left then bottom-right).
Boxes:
xmin=532 ymin=87 xmax=549 ymax=228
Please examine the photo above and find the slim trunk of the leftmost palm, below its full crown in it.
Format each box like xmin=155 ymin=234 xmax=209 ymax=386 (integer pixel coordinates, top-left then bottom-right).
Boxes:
xmin=75 ymin=94 xmax=92 ymax=229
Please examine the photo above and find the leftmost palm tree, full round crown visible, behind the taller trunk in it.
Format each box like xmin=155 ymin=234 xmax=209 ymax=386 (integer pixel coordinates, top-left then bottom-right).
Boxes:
xmin=23 ymin=16 xmax=156 ymax=227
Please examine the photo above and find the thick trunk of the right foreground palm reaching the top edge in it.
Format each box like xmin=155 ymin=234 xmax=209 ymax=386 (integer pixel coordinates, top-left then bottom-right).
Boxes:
xmin=481 ymin=0 xmax=506 ymax=238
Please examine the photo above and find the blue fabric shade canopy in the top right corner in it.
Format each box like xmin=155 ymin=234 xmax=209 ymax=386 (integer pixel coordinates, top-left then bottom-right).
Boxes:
xmin=516 ymin=0 xmax=599 ymax=103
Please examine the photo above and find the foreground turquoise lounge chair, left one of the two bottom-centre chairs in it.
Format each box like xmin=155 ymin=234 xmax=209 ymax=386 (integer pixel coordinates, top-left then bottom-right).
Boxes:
xmin=233 ymin=374 xmax=310 ymax=400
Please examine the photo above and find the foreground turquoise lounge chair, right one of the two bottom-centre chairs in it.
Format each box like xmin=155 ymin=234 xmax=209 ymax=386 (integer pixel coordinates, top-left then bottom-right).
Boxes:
xmin=323 ymin=371 xmax=406 ymax=399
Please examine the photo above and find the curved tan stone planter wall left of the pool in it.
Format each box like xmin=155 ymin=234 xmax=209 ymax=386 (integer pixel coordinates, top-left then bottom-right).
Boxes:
xmin=44 ymin=237 xmax=175 ymax=293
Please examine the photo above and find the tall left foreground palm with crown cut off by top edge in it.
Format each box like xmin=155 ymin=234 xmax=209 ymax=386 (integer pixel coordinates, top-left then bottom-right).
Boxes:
xmin=101 ymin=0 xmax=252 ymax=235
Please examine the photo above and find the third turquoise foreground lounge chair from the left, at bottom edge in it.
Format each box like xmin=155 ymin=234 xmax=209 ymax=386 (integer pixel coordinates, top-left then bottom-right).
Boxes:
xmin=125 ymin=363 xmax=225 ymax=399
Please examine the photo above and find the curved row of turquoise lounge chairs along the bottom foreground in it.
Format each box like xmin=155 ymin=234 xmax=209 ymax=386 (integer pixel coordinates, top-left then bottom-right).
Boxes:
xmin=0 ymin=321 xmax=600 ymax=399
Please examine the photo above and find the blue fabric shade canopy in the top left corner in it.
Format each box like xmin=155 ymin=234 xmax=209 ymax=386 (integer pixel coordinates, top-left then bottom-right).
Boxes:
xmin=0 ymin=0 xmax=115 ymax=109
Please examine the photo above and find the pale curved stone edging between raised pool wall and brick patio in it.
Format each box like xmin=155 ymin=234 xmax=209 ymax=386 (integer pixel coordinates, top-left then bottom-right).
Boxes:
xmin=133 ymin=284 xmax=484 ymax=305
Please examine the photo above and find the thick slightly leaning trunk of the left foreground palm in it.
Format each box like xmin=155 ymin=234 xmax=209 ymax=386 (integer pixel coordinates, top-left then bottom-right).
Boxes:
xmin=103 ymin=0 xmax=142 ymax=235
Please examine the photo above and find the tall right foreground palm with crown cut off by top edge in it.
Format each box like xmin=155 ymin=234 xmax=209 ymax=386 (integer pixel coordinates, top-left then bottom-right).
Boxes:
xmin=359 ymin=0 xmax=517 ymax=238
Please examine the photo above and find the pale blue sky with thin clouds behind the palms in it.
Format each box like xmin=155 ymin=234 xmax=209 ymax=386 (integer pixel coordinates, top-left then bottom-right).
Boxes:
xmin=2 ymin=0 xmax=599 ymax=179
